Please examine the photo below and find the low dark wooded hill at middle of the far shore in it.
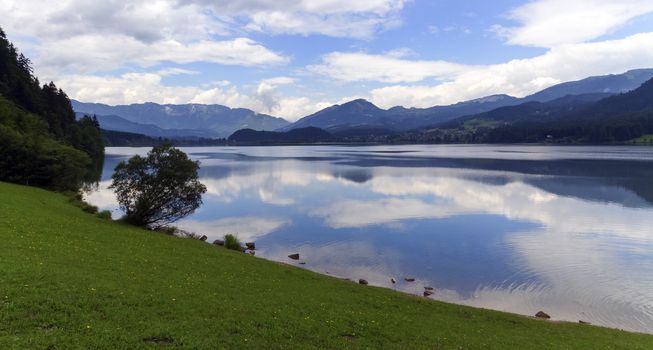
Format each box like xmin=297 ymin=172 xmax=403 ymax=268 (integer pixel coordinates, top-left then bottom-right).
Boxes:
xmin=229 ymin=127 xmax=334 ymax=145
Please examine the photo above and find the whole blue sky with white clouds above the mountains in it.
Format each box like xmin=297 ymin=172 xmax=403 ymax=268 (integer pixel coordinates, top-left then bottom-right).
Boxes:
xmin=0 ymin=0 xmax=653 ymax=121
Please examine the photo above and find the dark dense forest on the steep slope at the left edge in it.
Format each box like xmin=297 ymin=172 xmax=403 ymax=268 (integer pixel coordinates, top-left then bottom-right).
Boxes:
xmin=0 ymin=28 xmax=104 ymax=190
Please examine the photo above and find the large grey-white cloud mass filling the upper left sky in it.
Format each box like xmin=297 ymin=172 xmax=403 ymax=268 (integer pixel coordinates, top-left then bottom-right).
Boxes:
xmin=0 ymin=0 xmax=405 ymax=75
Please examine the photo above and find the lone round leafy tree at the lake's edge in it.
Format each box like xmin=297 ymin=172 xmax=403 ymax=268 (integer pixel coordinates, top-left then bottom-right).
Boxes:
xmin=109 ymin=144 xmax=206 ymax=229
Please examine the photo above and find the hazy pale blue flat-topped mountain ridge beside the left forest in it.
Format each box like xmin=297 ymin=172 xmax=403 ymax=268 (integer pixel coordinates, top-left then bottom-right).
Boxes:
xmin=72 ymin=100 xmax=289 ymax=138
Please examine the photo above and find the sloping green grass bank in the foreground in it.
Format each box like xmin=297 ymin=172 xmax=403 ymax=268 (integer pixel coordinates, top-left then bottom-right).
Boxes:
xmin=0 ymin=183 xmax=653 ymax=349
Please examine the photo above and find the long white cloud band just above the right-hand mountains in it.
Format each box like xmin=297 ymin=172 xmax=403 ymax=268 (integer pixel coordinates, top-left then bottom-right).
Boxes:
xmin=310 ymin=33 xmax=653 ymax=108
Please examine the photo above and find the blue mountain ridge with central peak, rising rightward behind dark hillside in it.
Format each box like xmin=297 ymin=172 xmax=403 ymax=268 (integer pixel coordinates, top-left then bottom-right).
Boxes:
xmin=280 ymin=69 xmax=653 ymax=135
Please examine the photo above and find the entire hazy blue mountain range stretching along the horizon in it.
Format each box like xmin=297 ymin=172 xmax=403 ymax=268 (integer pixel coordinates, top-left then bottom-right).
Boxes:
xmin=72 ymin=69 xmax=653 ymax=138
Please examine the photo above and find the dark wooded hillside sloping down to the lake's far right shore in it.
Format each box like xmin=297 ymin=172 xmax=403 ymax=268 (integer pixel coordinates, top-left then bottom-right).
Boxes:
xmin=416 ymin=79 xmax=653 ymax=143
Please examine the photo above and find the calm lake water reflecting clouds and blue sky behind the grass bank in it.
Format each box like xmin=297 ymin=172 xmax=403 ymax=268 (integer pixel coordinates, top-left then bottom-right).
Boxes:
xmin=88 ymin=146 xmax=653 ymax=333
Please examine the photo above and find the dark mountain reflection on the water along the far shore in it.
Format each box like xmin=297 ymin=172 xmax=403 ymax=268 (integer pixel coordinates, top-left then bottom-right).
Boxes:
xmin=181 ymin=150 xmax=653 ymax=207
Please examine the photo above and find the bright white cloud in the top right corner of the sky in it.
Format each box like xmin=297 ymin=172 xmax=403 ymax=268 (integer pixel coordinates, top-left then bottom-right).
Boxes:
xmin=492 ymin=0 xmax=653 ymax=47
